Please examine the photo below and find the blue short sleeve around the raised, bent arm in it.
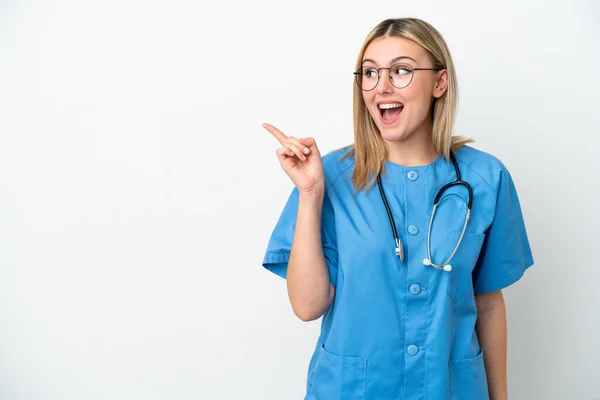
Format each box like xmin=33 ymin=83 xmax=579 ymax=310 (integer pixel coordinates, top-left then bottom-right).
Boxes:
xmin=262 ymin=188 xmax=338 ymax=286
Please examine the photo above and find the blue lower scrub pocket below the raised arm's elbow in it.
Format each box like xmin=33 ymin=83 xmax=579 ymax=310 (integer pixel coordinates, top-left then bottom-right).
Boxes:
xmin=305 ymin=345 xmax=367 ymax=400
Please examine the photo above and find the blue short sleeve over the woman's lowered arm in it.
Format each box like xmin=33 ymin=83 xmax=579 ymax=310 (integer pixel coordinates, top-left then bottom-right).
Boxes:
xmin=473 ymin=168 xmax=533 ymax=294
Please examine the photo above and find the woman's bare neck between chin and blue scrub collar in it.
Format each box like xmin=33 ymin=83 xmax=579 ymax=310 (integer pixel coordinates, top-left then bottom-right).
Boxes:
xmin=386 ymin=122 xmax=438 ymax=167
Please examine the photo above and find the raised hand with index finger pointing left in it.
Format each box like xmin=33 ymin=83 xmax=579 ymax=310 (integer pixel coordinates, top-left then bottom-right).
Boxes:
xmin=263 ymin=124 xmax=325 ymax=194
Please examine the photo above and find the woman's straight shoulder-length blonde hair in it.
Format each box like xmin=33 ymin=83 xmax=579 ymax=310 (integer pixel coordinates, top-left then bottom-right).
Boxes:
xmin=343 ymin=18 xmax=473 ymax=190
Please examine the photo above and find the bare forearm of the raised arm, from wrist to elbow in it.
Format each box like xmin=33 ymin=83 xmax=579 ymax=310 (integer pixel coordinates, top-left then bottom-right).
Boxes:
xmin=287 ymin=192 xmax=334 ymax=321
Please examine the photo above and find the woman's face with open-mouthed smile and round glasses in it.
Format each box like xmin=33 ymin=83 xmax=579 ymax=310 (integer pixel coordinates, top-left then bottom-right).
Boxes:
xmin=362 ymin=37 xmax=447 ymax=142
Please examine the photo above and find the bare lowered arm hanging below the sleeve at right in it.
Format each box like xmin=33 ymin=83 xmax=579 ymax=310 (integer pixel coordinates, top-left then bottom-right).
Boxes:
xmin=475 ymin=291 xmax=508 ymax=400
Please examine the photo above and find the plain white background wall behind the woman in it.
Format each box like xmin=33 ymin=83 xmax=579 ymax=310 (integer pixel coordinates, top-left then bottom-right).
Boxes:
xmin=0 ymin=0 xmax=600 ymax=400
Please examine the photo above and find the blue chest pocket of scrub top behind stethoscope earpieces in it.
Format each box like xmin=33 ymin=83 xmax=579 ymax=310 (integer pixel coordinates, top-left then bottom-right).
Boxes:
xmin=431 ymin=231 xmax=485 ymax=303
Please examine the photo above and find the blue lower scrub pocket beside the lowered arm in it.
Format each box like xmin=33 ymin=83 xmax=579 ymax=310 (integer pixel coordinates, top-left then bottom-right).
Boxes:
xmin=450 ymin=349 xmax=490 ymax=400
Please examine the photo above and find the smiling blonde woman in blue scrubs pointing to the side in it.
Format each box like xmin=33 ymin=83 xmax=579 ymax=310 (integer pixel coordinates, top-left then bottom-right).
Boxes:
xmin=263 ymin=18 xmax=533 ymax=400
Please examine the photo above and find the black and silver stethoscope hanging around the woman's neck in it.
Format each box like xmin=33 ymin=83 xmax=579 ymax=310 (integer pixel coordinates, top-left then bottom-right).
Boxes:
xmin=377 ymin=151 xmax=473 ymax=272
